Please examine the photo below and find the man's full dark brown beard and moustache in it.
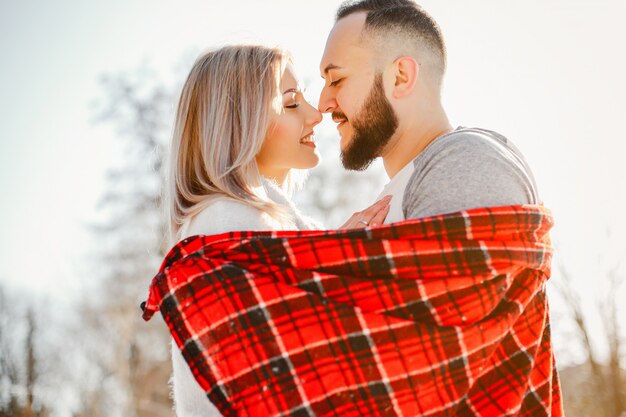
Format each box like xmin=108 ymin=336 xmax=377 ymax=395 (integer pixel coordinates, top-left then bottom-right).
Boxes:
xmin=333 ymin=74 xmax=398 ymax=171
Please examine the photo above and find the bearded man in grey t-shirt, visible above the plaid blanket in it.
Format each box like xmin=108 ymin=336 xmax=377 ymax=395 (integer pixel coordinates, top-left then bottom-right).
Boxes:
xmin=319 ymin=0 xmax=539 ymax=223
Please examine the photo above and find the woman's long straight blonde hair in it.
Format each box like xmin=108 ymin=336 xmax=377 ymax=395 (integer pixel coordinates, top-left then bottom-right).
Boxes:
xmin=165 ymin=45 xmax=290 ymax=244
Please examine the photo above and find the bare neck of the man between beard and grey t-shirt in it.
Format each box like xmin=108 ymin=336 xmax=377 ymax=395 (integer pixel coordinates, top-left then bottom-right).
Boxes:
xmin=382 ymin=106 xmax=453 ymax=178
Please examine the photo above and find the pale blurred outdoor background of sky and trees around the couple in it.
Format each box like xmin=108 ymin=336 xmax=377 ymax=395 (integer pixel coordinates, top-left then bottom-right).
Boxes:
xmin=0 ymin=0 xmax=626 ymax=417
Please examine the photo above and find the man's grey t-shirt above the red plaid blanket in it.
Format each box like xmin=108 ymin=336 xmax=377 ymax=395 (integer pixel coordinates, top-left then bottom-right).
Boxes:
xmin=402 ymin=128 xmax=539 ymax=219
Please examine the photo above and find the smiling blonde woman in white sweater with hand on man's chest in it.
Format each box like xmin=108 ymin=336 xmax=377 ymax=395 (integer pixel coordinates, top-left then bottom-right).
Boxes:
xmin=167 ymin=46 xmax=389 ymax=417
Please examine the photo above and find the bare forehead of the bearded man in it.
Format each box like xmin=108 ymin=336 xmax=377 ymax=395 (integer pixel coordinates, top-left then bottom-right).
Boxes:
xmin=320 ymin=12 xmax=367 ymax=76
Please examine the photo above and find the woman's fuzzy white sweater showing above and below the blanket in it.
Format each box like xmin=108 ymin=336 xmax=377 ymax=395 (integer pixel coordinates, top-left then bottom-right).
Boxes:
xmin=170 ymin=180 xmax=319 ymax=417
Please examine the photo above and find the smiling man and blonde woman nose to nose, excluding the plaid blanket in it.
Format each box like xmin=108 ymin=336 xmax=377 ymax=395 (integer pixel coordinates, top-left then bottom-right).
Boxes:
xmin=154 ymin=0 xmax=558 ymax=417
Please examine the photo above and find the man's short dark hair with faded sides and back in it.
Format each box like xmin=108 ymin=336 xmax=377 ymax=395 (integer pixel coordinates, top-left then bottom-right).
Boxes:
xmin=336 ymin=0 xmax=446 ymax=81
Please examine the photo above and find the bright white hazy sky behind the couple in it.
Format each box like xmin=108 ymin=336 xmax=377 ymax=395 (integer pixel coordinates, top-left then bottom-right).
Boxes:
xmin=0 ymin=0 xmax=626 ymax=360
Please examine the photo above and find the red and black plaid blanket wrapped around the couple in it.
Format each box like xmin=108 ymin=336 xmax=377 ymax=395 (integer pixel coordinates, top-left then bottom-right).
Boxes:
xmin=143 ymin=206 xmax=562 ymax=417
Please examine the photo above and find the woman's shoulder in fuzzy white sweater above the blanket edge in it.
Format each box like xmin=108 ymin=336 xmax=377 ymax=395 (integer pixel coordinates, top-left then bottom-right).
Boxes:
xmin=181 ymin=197 xmax=277 ymax=239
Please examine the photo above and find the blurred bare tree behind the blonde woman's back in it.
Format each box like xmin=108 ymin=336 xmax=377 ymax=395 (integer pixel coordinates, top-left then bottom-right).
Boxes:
xmin=65 ymin=71 xmax=177 ymax=417
